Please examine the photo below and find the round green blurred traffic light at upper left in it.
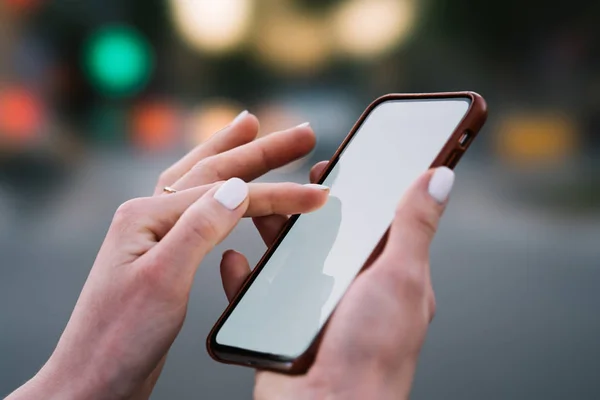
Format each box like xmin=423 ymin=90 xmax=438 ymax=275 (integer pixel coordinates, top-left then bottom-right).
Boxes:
xmin=84 ymin=25 xmax=154 ymax=96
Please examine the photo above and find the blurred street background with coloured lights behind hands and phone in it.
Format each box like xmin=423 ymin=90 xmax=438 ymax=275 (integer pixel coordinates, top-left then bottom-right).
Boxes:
xmin=0 ymin=0 xmax=600 ymax=399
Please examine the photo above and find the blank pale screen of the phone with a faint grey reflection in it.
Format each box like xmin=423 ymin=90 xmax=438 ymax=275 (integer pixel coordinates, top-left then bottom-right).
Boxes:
xmin=216 ymin=98 xmax=470 ymax=358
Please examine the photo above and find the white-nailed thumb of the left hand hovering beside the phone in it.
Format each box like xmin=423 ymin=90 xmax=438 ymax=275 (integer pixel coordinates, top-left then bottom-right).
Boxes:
xmin=146 ymin=178 xmax=248 ymax=284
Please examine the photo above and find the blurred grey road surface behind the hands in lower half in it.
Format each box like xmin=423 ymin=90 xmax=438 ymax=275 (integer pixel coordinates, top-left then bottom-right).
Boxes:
xmin=0 ymin=152 xmax=600 ymax=400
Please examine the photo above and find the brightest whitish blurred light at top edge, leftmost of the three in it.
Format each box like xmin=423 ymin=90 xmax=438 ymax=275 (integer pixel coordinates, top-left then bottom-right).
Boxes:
xmin=170 ymin=0 xmax=253 ymax=53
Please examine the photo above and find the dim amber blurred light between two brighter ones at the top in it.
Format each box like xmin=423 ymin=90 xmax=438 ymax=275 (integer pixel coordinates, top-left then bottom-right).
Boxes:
xmin=255 ymin=13 xmax=332 ymax=73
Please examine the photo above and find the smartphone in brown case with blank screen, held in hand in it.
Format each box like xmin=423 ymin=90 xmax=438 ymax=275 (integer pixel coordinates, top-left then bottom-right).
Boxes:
xmin=207 ymin=92 xmax=487 ymax=374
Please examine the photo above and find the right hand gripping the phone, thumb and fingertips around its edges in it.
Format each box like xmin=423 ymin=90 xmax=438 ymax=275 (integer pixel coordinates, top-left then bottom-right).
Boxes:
xmin=221 ymin=164 xmax=454 ymax=400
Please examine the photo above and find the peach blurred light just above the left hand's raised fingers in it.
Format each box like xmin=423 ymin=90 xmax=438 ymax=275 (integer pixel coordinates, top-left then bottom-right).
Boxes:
xmin=186 ymin=100 xmax=242 ymax=146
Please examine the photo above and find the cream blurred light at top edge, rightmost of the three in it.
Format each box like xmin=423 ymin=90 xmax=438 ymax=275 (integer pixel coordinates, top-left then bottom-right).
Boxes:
xmin=333 ymin=0 xmax=416 ymax=57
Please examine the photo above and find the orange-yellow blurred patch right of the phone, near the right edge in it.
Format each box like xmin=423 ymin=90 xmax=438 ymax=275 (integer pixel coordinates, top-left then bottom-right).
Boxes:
xmin=496 ymin=112 xmax=580 ymax=163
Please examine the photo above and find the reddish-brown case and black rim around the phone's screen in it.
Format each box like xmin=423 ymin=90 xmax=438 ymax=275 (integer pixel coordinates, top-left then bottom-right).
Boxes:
xmin=206 ymin=92 xmax=487 ymax=375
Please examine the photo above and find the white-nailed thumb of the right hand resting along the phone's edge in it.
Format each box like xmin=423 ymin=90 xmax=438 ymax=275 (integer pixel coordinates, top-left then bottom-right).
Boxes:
xmin=384 ymin=167 xmax=454 ymax=265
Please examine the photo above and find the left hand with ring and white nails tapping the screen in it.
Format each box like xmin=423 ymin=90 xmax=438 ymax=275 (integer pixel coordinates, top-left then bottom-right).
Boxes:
xmin=9 ymin=114 xmax=327 ymax=399
